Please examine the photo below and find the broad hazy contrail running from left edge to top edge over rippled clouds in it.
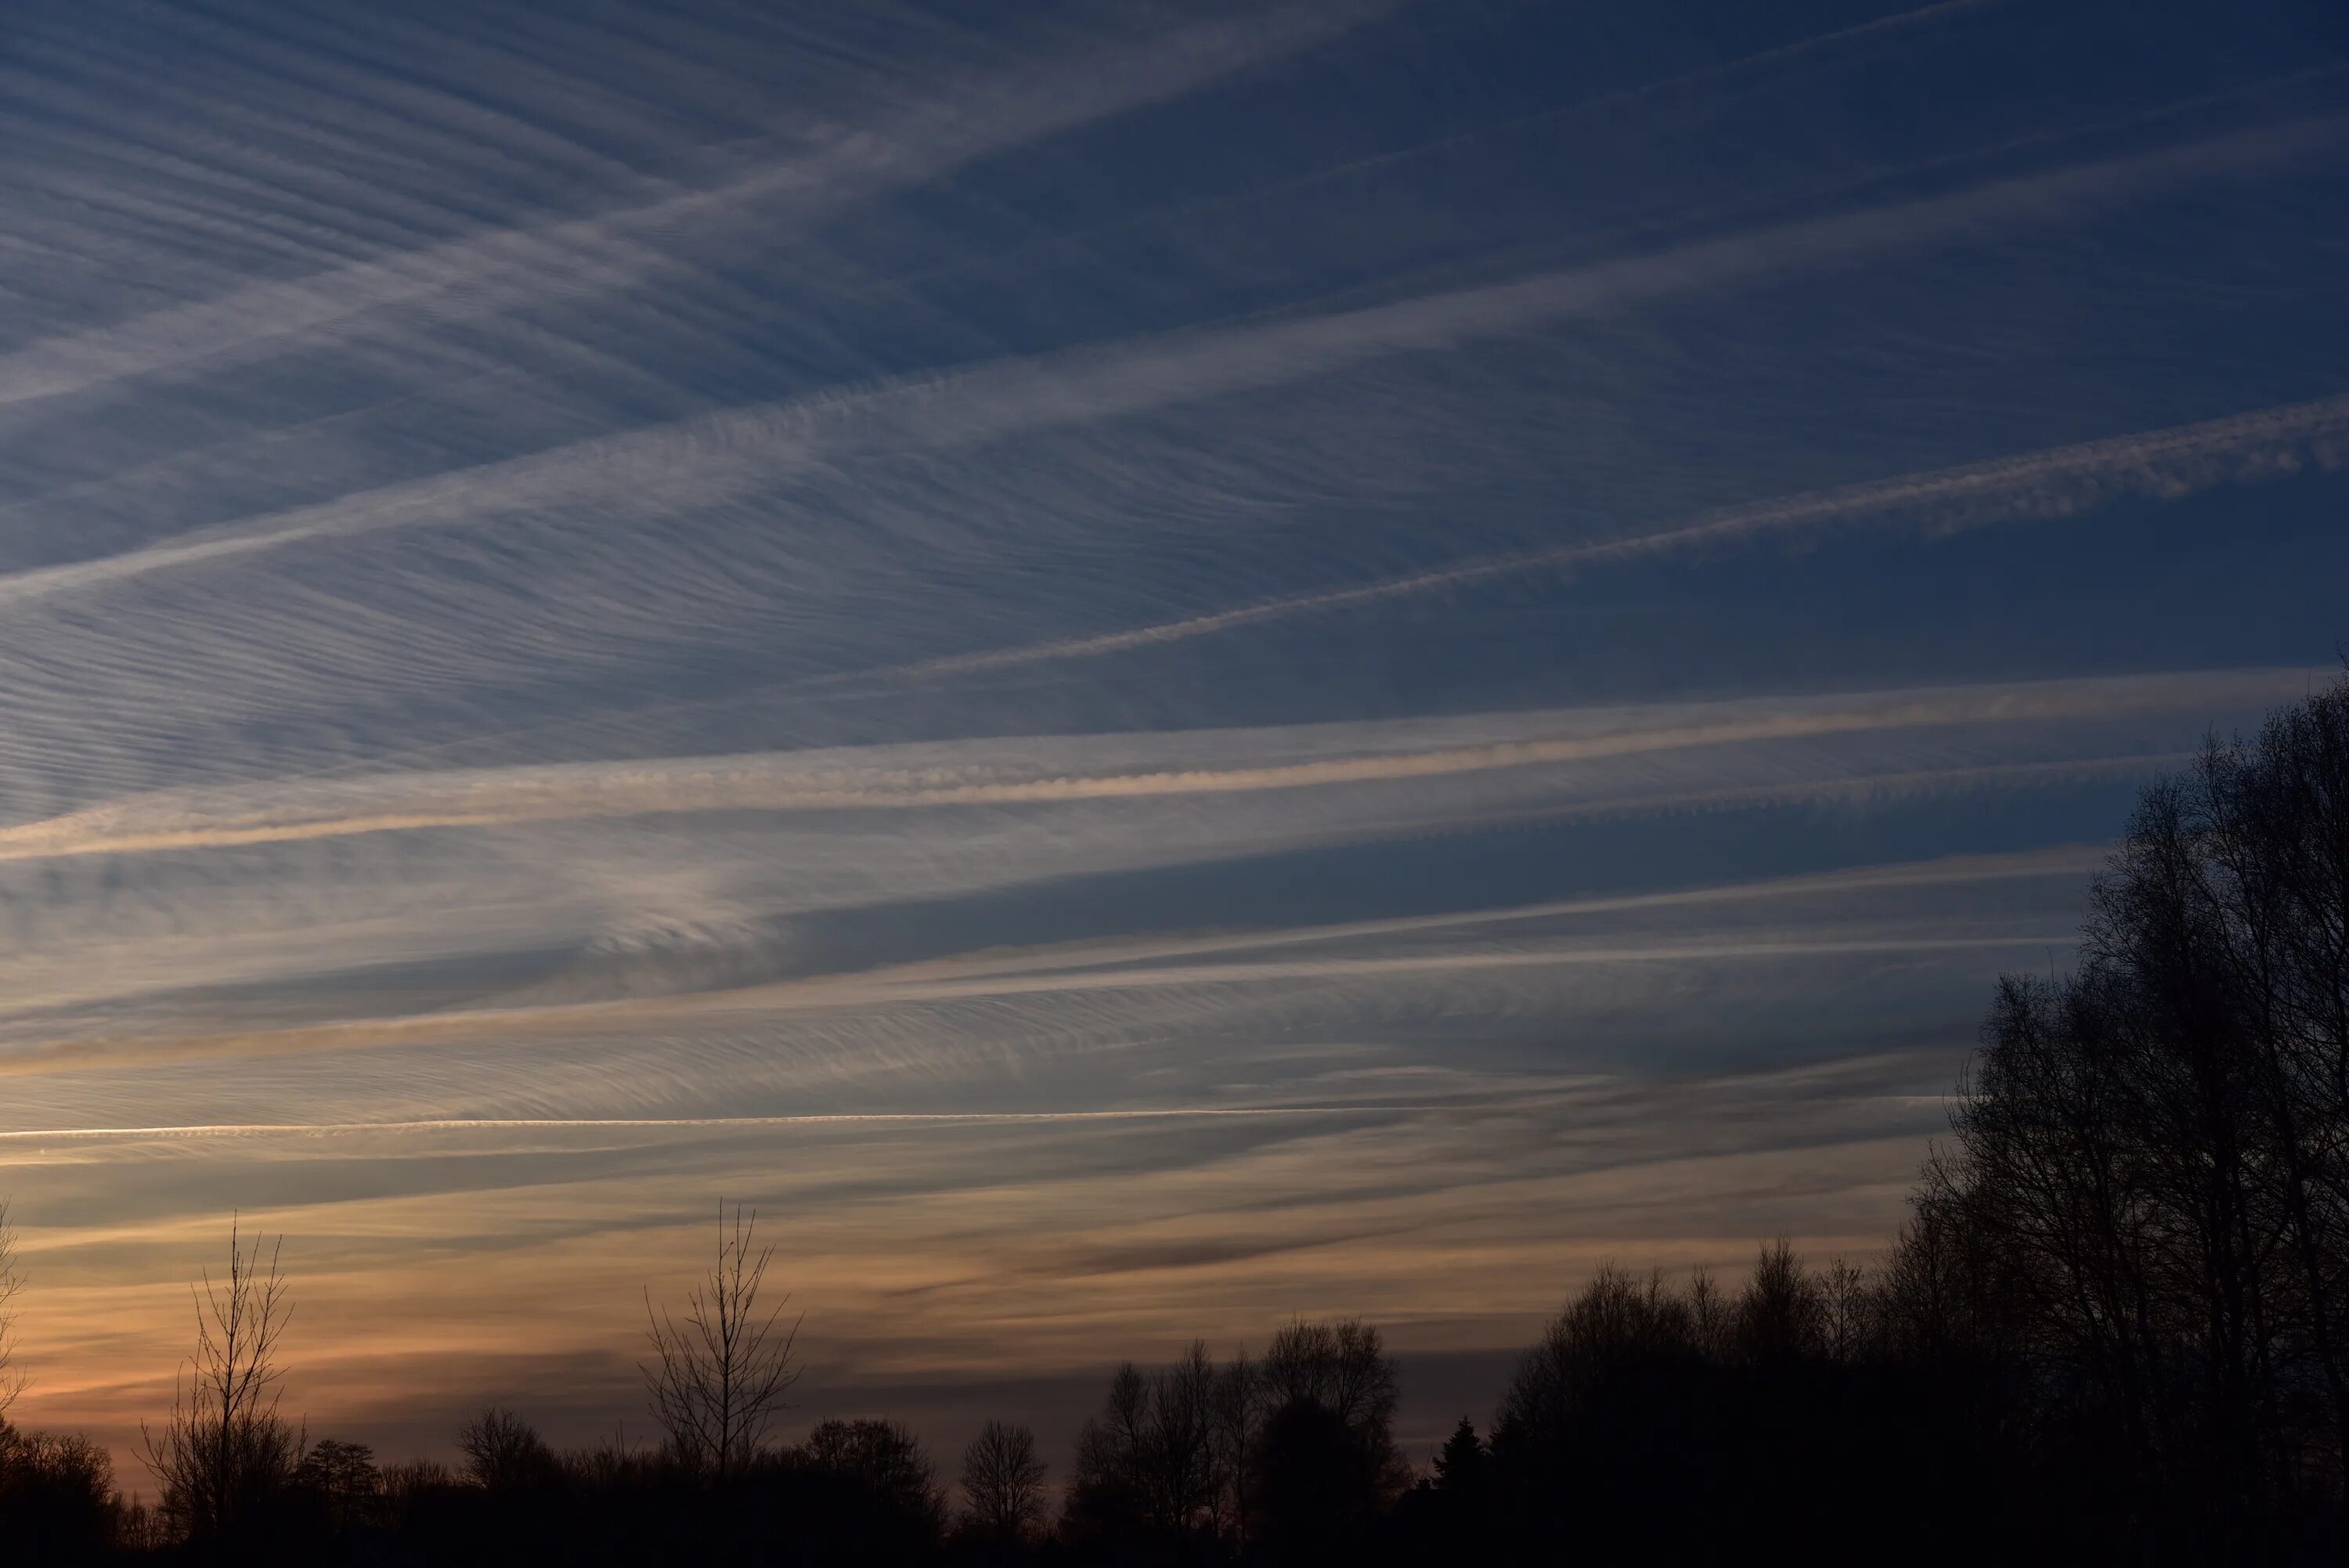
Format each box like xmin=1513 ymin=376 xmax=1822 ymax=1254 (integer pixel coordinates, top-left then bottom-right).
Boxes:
xmin=0 ymin=0 xmax=1393 ymax=406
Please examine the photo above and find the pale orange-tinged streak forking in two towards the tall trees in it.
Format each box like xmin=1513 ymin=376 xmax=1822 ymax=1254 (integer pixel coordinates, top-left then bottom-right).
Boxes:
xmin=0 ymin=845 xmax=2098 ymax=1091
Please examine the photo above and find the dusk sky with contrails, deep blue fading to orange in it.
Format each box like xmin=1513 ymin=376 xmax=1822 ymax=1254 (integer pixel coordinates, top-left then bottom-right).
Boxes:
xmin=0 ymin=0 xmax=2349 ymax=1486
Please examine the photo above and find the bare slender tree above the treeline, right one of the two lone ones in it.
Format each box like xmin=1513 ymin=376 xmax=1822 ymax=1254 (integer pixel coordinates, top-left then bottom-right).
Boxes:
xmin=639 ymin=1204 xmax=799 ymax=1481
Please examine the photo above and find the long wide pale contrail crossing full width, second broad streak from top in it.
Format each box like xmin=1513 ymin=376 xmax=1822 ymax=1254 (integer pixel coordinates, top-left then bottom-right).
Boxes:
xmin=0 ymin=117 xmax=2349 ymax=606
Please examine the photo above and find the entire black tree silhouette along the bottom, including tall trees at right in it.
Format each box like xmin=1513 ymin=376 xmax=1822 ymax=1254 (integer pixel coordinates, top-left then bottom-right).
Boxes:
xmin=0 ymin=679 xmax=2349 ymax=1566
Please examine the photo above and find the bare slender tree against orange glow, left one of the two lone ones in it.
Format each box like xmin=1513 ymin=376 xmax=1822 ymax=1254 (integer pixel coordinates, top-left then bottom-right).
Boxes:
xmin=141 ymin=1223 xmax=303 ymax=1537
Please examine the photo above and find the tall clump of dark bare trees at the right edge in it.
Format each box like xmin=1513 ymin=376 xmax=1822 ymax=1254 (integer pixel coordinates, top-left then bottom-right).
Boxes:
xmin=1936 ymin=681 xmax=2349 ymax=1533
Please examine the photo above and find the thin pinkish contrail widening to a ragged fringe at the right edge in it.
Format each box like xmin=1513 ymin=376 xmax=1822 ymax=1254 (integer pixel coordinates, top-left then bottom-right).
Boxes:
xmin=879 ymin=395 xmax=2349 ymax=683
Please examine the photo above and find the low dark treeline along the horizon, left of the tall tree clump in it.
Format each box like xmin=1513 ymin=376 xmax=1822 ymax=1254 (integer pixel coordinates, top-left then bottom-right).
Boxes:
xmin=0 ymin=1218 xmax=2004 ymax=1566
